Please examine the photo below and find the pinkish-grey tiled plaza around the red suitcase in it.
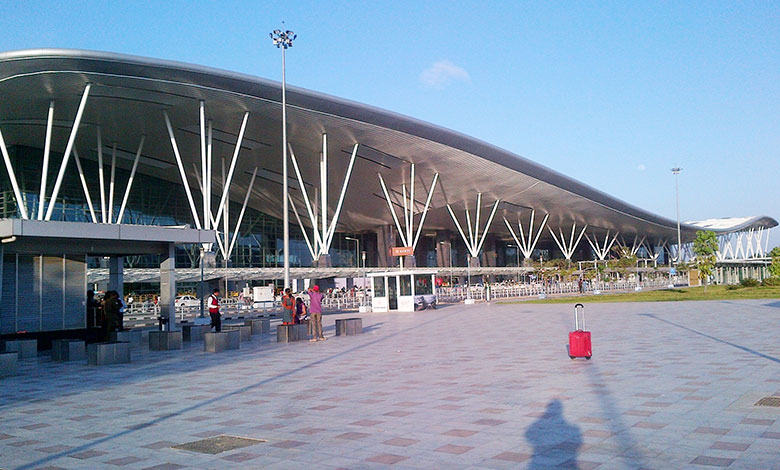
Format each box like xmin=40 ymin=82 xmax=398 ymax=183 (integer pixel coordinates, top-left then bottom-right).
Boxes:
xmin=0 ymin=300 xmax=780 ymax=469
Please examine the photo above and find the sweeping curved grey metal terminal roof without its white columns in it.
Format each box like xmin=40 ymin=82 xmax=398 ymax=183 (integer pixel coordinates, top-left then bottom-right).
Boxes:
xmin=0 ymin=49 xmax=777 ymax=246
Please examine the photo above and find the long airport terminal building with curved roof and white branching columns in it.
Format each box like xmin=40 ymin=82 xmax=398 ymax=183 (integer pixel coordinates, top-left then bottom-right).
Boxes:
xmin=0 ymin=49 xmax=777 ymax=333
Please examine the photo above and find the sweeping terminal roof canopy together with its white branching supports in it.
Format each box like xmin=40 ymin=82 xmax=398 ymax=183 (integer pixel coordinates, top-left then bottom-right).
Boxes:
xmin=0 ymin=49 xmax=777 ymax=266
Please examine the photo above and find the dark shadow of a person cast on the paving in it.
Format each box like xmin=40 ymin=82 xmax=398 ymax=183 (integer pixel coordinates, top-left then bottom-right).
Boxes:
xmin=525 ymin=398 xmax=582 ymax=470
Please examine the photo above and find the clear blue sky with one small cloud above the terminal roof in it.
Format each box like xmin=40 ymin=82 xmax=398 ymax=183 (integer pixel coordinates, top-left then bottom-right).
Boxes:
xmin=0 ymin=0 xmax=780 ymax=243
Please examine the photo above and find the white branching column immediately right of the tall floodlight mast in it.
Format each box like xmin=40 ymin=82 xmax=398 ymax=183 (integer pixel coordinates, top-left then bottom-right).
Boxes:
xmin=288 ymin=134 xmax=358 ymax=267
